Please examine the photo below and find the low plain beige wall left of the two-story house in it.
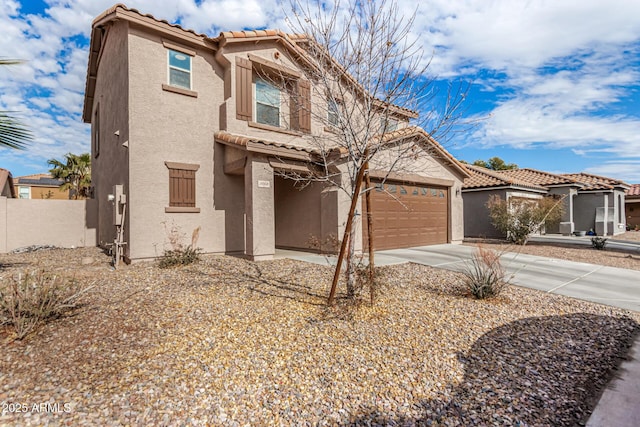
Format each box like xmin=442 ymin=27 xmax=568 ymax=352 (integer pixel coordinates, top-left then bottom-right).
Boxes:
xmin=0 ymin=197 xmax=96 ymax=252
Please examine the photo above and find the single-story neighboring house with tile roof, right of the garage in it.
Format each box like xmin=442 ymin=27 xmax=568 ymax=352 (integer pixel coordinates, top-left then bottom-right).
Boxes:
xmin=462 ymin=165 xmax=628 ymax=238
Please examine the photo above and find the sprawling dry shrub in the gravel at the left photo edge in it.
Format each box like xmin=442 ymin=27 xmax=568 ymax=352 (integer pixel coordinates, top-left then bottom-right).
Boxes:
xmin=0 ymin=270 xmax=92 ymax=339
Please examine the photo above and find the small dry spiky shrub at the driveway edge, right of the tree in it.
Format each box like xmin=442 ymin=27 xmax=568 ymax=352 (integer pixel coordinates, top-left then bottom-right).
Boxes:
xmin=462 ymin=246 xmax=508 ymax=299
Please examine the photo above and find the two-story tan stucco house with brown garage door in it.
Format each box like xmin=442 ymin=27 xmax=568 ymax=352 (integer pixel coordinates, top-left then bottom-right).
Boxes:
xmin=83 ymin=4 xmax=468 ymax=260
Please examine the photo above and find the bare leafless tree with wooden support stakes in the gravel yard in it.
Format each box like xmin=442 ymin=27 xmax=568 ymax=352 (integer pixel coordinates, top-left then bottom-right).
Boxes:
xmin=270 ymin=0 xmax=468 ymax=305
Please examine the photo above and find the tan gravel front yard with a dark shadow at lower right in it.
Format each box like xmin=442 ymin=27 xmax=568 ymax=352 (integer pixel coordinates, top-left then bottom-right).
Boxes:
xmin=0 ymin=248 xmax=640 ymax=426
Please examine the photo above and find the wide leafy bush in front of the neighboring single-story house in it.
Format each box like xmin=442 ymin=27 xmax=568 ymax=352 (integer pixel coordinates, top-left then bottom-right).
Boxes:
xmin=486 ymin=195 xmax=564 ymax=245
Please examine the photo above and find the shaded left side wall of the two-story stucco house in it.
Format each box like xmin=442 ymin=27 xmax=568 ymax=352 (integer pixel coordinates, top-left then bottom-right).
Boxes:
xmin=91 ymin=21 xmax=129 ymax=251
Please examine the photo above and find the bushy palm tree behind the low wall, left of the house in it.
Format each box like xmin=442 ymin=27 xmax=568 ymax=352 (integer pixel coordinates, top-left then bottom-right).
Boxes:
xmin=47 ymin=153 xmax=91 ymax=200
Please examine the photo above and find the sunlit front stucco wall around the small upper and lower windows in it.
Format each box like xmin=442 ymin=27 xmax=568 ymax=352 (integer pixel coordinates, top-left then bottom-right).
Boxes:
xmin=128 ymin=28 xmax=225 ymax=258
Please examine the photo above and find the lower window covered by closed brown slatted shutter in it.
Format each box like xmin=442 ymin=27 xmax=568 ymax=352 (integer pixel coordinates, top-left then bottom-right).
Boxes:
xmin=164 ymin=162 xmax=200 ymax=212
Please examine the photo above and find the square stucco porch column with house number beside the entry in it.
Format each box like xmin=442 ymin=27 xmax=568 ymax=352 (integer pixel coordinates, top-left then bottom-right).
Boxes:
xmin=244 ymin=155 xmax=276 ymax=261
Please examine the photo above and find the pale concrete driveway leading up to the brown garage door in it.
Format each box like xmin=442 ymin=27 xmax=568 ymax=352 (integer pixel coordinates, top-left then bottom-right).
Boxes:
xmin=278 ymin=244 xmax=640 ymax=311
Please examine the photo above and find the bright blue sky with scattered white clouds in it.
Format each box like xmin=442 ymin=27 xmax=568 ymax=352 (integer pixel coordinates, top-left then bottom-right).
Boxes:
xmin=0 ymin=0 xmax=640 ymax=183
